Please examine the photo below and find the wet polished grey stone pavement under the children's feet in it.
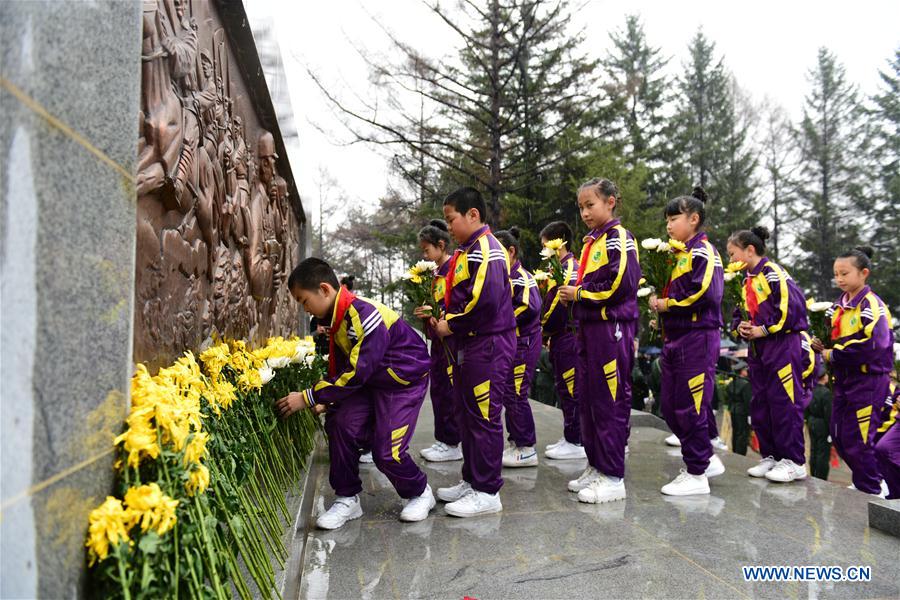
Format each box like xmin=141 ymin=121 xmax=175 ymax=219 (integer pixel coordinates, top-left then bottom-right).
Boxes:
xmin=300 ymin=402 xmax=900 ymax=599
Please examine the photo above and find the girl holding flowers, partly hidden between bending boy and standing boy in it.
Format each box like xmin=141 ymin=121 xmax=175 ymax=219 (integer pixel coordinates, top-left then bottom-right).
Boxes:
xmin=413 ymin=219 xmax=462 ymax=462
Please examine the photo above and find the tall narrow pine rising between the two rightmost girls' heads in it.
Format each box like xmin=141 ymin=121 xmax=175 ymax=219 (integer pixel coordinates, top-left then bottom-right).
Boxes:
xmin=791 ymin=48 xmax=867 ymax=298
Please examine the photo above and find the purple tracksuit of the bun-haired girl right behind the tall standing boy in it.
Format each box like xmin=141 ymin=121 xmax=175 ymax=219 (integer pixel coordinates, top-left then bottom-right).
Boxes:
xmin=503 ymin=260 xmax=541 ymax=448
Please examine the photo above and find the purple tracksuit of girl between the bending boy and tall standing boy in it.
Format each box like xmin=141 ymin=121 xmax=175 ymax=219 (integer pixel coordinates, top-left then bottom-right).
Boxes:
xmin=425 ymin=260 xmax=459 ymax=446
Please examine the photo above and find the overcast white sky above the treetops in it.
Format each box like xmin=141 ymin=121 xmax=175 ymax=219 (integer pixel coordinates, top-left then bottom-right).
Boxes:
xmin=245 ymin=0 xmax=900 ymax=225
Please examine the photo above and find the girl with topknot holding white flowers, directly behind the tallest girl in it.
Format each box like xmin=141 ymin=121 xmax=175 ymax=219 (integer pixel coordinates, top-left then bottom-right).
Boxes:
xmin=650 ymin=187 xmax=725 ymax=496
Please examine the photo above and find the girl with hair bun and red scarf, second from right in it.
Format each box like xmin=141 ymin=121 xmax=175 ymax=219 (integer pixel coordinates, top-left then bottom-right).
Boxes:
xmin=727 ymin=227 xmax=814 ymax=483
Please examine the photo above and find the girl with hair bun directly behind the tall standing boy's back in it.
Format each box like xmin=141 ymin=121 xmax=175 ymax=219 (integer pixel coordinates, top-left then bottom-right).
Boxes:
xmin=494 ymin=227 xmax=541 ymax=467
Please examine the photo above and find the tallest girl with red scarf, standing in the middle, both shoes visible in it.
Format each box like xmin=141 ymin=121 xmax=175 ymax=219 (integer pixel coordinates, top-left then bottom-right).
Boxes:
xmin=558 ymin=179 xmax=641 ymax=503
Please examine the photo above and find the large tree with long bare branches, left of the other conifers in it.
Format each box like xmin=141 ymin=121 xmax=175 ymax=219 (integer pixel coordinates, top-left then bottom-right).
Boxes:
xmin=309 ymin=0 xmax=606 ymax=220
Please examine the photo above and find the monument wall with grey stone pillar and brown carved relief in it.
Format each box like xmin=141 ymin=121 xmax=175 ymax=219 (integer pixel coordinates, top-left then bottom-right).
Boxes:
xmin=0 ymin=0 xmax=305 ymax=598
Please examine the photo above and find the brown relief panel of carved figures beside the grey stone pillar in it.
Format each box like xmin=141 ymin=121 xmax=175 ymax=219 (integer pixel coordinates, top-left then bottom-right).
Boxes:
xmin=134 ymin=0 xmax=303 ymax=366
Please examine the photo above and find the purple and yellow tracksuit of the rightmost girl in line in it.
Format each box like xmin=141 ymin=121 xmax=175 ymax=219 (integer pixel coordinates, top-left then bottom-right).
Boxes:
xmin=829 ymin=286 xmax=894 ymax=494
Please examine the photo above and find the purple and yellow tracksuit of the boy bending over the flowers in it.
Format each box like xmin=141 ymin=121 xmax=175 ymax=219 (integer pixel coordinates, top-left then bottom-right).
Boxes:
xmin=306 ymin=288 xmax=429 ymax=498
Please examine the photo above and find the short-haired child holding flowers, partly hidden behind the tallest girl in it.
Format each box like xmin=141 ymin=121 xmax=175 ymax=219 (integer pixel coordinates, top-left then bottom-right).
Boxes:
xmin=541 ymin=221 xmax=586 ymax=460
